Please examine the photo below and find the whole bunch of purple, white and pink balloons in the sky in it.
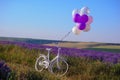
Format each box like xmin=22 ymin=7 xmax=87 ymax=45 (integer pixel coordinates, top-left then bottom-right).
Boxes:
xmin=72 ymin=7 xmax=93 ymax=35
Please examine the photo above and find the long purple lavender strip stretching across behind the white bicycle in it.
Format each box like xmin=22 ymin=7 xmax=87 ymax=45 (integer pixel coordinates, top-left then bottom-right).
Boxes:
xmin=0 ymin=41 xmax=120 ymax=63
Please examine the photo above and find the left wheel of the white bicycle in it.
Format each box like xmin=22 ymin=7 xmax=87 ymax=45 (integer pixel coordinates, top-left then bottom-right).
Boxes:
xmin=35 ymin=54 xmax=46 ymax=72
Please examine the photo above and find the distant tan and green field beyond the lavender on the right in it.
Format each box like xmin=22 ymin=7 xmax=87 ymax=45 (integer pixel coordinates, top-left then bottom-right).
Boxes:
xmin=46 ymin=42 xmax=120 ymax=53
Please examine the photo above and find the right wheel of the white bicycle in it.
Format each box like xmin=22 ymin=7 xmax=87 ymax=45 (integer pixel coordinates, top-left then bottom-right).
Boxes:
xmin=49 ymin=58 xmax=68 ymax=76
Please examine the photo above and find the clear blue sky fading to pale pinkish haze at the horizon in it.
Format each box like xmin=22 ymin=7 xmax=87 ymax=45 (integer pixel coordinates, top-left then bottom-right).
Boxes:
xmin=0 ymin=0 xmax=120 ymax=43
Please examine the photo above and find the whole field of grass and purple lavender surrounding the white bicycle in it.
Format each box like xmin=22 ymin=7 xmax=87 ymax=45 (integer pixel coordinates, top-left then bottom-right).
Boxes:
xmin=0 ymin=41 xmax=120 ymax=80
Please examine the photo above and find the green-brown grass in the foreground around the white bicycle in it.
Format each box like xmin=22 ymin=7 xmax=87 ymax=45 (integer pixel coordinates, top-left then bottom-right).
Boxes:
xmin=0 ymin=45 xmax=120 ymax=80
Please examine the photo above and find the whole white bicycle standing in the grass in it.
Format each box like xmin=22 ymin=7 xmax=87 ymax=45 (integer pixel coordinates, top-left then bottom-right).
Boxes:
xmin=35 ymin=48 xmax=68 ymax=76
